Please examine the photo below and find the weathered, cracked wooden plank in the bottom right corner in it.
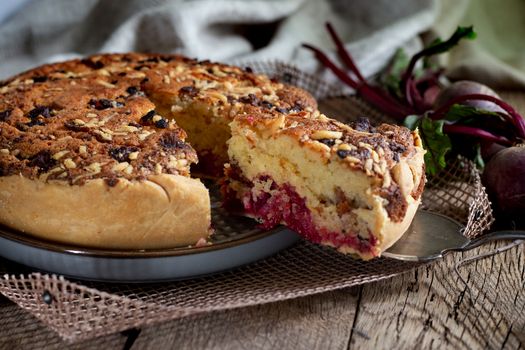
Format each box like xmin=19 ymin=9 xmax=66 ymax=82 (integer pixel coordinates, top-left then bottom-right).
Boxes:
xmin=350 ymin=243 xmax=525 ymax=349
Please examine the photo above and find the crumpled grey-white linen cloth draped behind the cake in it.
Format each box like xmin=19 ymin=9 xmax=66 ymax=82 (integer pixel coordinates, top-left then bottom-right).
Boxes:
xmin=0 ymin=0 xmax=437 ymax=85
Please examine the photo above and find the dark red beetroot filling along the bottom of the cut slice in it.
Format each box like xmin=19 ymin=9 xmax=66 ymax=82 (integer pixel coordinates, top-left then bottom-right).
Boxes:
xmin=225 ymin=176 xmax=377 ymax=253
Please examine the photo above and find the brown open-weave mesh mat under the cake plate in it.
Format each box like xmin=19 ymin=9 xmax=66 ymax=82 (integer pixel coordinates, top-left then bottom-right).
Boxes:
xmin=0 ymin=62 xmax=492 ymax=341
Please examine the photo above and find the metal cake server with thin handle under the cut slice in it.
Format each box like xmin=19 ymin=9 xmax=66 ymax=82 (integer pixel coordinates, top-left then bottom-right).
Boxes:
xmin=382 ymin=210 xmax=525 ymax=261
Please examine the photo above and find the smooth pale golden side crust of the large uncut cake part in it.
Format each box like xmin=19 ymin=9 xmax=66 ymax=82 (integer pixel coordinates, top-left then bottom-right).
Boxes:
xmin=0 ymin=174 xmax=210 ymax=249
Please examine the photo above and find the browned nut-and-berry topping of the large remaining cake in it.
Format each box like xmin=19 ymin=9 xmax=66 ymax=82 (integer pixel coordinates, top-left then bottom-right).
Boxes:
xmin=0 ymin=54 xmax=316 ymax=184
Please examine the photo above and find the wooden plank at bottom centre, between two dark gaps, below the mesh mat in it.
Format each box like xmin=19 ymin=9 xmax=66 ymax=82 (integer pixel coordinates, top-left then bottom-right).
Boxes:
xmin=134 ymin=288 xmax=359 ymax=350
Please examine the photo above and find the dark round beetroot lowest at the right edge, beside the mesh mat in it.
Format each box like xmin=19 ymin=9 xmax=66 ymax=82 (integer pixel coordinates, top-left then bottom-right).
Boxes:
xmin=482 ymin=145 xmax=525 ymax=227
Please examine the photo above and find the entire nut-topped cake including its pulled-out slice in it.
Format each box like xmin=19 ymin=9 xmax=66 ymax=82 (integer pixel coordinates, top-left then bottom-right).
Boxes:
xmin=0 ymin=53 xmax=424 ymax=259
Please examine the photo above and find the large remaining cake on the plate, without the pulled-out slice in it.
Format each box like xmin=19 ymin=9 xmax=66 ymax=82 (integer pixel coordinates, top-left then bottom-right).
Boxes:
xmin=0 ymin=54 xmax=315 ymax=249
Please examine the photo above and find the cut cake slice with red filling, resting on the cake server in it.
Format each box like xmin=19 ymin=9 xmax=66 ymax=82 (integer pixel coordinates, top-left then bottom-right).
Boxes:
xmin=223 ymin=112 xmax=425 ymax=259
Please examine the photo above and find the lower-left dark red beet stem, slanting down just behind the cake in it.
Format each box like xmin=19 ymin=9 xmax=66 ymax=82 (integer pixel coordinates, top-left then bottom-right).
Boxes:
xmin=303 ymin=44 xmax=411 ymax=120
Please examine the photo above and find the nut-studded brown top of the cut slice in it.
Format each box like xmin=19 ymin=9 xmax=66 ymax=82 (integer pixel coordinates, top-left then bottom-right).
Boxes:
xmin=232 ymin=111 xmax=415 ymax=176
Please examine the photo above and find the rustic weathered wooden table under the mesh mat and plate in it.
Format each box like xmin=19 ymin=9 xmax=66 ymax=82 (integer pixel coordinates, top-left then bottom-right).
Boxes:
xmin=0 ymin=93 xmax=525 ymax=350
